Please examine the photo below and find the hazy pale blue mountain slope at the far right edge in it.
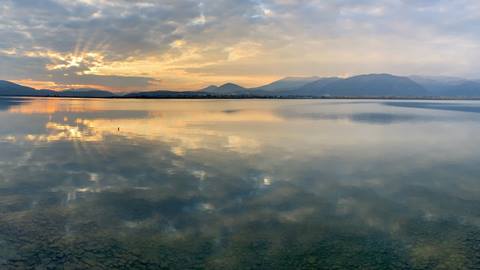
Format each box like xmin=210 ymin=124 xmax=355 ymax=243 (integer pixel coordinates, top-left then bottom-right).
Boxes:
xmin=410 ymin=76 xmax=480 ymax=98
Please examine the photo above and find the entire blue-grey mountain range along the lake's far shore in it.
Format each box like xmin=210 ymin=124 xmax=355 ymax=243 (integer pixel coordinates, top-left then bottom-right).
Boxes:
xmin=0 ymin=74 xmax=480 ymax=98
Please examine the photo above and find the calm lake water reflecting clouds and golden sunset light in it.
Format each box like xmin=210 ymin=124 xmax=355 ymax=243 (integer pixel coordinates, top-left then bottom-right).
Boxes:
xmin=0 ymin=98 xmax=480 ymax=269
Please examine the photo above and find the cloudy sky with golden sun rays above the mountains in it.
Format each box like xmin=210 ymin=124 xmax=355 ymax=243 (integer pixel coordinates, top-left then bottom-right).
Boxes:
xmin=0 ymin=0 xmax=480 ymax=91
